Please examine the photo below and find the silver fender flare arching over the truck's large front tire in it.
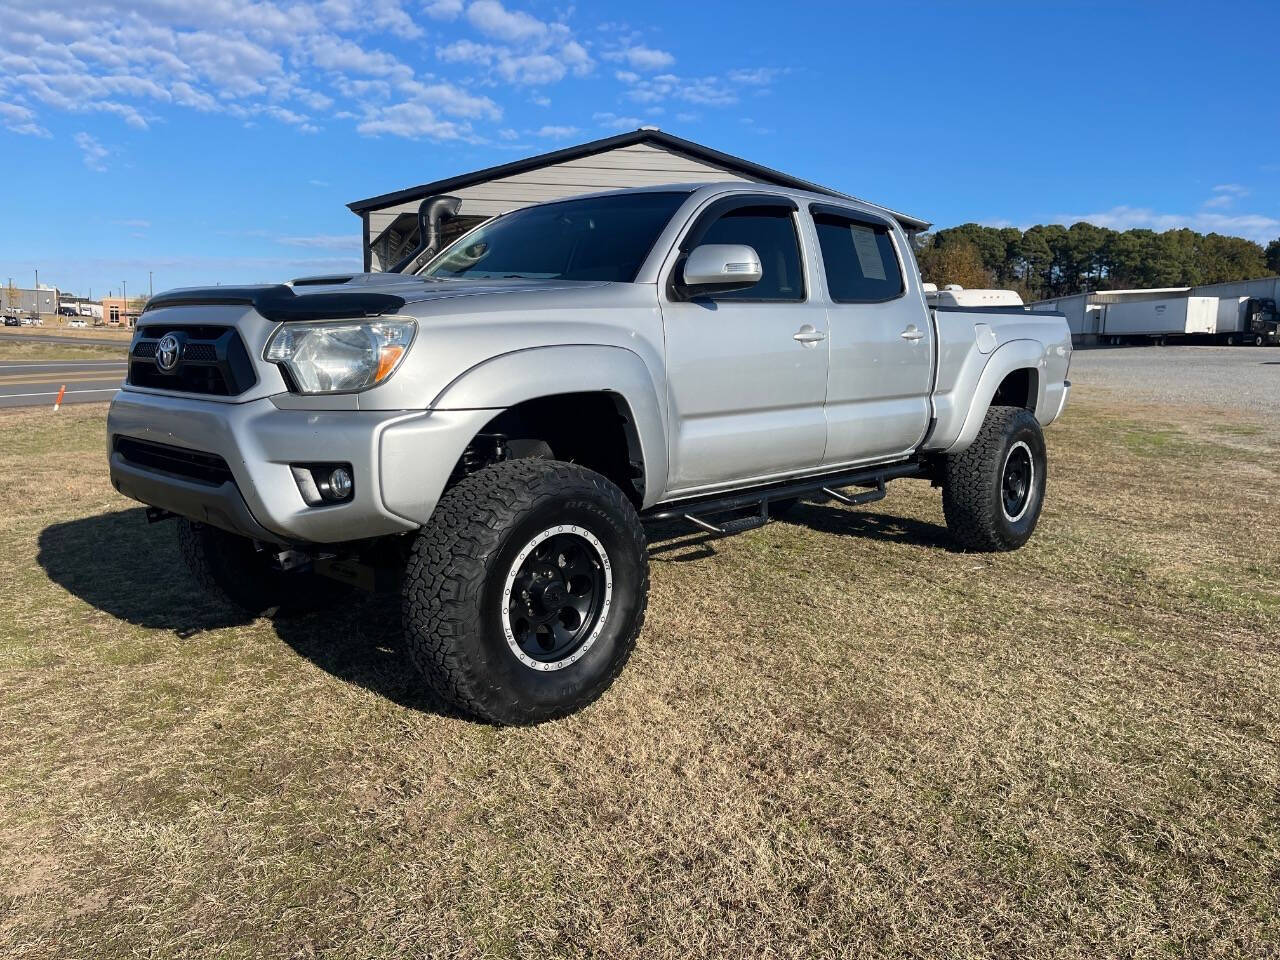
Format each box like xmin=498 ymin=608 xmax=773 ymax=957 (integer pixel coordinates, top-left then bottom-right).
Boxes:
xmin=428 ymin=344 xmax=668 ymax=507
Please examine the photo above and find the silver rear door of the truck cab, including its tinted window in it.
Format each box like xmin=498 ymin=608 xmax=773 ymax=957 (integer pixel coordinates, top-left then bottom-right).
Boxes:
xmin=809 ymin=204 xmax=936 ymax=466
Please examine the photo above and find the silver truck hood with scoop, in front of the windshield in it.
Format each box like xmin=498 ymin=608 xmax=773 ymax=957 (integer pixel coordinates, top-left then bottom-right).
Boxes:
xmin=142 ymin=274 xmax=604 ymax=321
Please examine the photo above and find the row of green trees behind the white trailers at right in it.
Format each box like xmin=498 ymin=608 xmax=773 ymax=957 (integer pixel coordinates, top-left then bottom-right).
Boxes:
xmin=915 ymin=221 xmax=1280 ymax=302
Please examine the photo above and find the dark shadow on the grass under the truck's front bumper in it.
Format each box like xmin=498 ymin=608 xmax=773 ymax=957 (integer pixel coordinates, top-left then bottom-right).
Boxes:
xmin=37 ymin=508 xmax=454 ymax=716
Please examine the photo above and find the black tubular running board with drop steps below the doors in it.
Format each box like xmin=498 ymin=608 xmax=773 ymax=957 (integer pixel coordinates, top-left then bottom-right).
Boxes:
xmin=641 ymin=461 xmax=925 ymax=536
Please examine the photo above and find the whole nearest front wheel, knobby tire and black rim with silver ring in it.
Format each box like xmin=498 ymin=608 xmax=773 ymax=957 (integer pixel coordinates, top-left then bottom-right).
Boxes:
xmin=402 ymin=460 xmax=649 ymax=724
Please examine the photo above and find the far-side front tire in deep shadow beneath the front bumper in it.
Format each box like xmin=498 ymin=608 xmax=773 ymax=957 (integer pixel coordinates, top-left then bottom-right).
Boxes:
xmin=177 ymin=518 xmax=347 ymax=616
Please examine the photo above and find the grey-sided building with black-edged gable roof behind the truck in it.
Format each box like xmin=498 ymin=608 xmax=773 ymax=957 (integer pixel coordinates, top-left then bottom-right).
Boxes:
xmin=347 ymin=127 xmax=929 ymax=271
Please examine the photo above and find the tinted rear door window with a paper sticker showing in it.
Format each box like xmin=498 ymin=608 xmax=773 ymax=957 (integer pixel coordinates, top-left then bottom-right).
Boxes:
xmin=813 ymin=211 xmax=905 ymax=303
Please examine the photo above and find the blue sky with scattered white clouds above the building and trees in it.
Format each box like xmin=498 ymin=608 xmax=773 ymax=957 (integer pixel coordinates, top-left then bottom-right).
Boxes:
xmin=0 ymin=0 xmax=1280 ymax=296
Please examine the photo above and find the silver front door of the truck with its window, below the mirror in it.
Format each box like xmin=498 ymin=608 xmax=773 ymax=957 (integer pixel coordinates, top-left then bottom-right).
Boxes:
xmin=662 ymin=195 xmax=828 ymax=494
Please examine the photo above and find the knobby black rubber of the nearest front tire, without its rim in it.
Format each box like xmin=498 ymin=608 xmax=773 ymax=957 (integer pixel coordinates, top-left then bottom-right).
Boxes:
xmin=402 ymin=460 xmax=649 ymax=724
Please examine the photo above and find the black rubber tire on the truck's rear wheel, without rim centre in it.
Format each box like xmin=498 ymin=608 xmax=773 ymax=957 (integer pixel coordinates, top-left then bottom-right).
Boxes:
xmin=942 ymin=407 xmax=1048 ymax=553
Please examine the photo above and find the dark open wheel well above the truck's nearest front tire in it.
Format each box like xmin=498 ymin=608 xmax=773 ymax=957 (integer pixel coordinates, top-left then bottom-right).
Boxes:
xmin=449 ymin=392 xmax=644 ymax=506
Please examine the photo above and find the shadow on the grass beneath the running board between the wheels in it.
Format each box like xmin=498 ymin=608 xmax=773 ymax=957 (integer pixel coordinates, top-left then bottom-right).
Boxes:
xmin=648 ymin=502 xmax=955 ymax=563
